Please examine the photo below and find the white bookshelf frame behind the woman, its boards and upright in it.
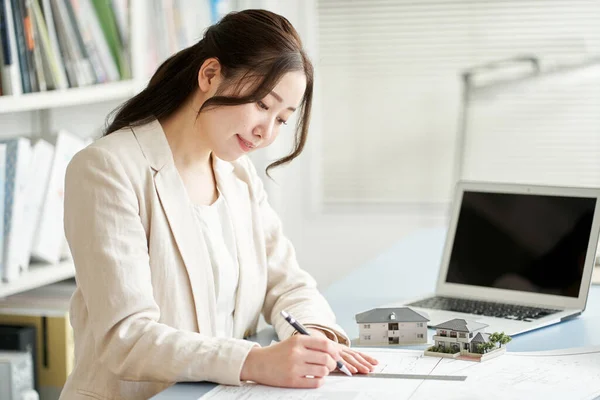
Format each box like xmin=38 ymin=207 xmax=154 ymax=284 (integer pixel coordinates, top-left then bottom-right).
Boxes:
xmin=0 ymin=0 xmax=149 ymax=299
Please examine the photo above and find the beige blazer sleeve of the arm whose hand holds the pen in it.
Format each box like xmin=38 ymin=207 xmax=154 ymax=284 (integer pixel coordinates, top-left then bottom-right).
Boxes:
xmin=64 ymin=147 xmax=256 ymax=385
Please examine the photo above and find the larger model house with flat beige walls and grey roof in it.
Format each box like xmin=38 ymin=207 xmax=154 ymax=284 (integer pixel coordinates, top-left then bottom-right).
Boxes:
xmin=356 ymin=307 xmax=429 ymax=345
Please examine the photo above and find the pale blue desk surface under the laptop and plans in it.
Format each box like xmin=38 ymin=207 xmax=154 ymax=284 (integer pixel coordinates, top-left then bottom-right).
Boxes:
xmin=153 ymin=229 xmax=600 ymax=400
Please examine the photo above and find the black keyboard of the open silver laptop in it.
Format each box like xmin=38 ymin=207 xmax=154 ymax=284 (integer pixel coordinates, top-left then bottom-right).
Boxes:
xmin=407 ymin=296 xmax=560 ymax=322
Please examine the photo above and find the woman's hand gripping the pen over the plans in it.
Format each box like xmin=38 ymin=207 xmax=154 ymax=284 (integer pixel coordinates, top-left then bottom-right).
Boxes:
xmin=240 ymin=335 xmax=340 ymax=388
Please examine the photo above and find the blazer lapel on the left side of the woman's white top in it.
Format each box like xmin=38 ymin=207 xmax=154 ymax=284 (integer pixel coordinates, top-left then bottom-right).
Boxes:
xmin=134 ymin=121 xmax=216 ymax=336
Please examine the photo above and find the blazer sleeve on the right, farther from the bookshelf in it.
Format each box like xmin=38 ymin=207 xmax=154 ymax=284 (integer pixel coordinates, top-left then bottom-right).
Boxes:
xmin=245 ymin=157 xmax=350 ymax=345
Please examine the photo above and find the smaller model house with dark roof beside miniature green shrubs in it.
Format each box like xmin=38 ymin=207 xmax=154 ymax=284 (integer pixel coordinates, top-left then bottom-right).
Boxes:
xmin=433 ymin=319 xmax=490 ymax=353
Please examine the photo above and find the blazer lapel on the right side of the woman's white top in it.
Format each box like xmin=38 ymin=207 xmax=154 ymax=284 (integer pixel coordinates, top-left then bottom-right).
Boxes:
xmin=213 ymin=156 xmax=256 ymax=338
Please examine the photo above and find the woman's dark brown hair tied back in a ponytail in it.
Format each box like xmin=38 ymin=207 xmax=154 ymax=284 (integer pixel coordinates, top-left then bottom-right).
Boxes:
xmin=105 ymin=10 xmax=313 ymax=173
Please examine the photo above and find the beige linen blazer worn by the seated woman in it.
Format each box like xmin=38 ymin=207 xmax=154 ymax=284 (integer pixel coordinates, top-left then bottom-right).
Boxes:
xmin=61 ymin=121 xmax=347 ymax=400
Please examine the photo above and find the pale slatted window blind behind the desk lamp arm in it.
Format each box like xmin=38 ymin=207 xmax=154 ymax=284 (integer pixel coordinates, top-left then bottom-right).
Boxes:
xmin=316 ymin=0 xmax=600 ymax=206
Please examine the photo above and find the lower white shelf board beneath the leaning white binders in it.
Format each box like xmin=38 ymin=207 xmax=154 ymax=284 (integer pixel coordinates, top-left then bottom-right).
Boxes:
xmin=0 ymin=261 xmax=75 ymax=299
